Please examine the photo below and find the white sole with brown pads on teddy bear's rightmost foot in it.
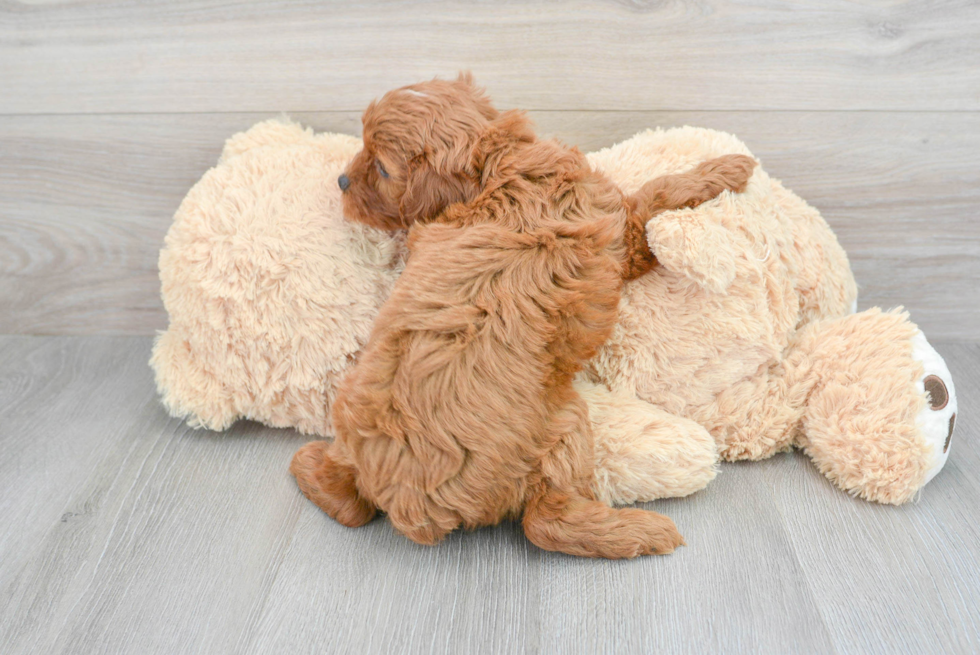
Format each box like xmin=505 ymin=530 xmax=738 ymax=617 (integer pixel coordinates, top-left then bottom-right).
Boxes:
xmin=912 ymin=331 xmax=956 ymax=484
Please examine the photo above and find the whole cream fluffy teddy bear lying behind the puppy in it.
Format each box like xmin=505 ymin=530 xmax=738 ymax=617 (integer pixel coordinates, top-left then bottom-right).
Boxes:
xmin=151 ymin=120 xmax=956 ymax=503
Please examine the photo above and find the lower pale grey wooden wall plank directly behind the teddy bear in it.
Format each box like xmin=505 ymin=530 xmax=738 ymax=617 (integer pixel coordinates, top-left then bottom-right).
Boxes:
xmin=0 ymin=112 xmax=980 ymax=340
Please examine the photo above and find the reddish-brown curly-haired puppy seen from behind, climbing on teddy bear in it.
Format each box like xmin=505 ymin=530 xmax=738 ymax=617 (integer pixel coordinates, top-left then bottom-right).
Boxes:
xmin=291 ymin=76 xmax=755 ymax=558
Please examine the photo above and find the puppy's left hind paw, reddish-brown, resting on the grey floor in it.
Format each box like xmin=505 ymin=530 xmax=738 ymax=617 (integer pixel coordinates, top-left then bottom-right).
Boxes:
xmin=289 ymin=441 xmax=377 ymax=528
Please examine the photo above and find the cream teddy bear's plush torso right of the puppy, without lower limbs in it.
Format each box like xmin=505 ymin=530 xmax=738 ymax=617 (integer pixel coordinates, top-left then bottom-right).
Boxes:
xmin=593 ymin=128 xmax=857 ymax=458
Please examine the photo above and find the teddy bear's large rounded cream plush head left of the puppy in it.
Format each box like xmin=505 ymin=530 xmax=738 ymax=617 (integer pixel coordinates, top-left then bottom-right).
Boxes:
xmin=151 ymin=120 xmax=404 ymax=435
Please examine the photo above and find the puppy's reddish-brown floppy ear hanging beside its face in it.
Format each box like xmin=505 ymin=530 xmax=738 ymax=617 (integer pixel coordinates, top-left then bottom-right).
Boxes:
xmin=398 ymin=154 xmax=479 ymax=227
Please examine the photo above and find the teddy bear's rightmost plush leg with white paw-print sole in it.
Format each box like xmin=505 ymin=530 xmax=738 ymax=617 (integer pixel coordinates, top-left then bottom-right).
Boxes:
xmin=797 ymin=309 xmax=956 ymax=505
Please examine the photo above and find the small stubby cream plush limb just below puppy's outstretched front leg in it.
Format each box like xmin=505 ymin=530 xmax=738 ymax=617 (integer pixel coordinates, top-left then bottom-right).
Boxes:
xmin=647 ymin=209 xmax=746 ymax=294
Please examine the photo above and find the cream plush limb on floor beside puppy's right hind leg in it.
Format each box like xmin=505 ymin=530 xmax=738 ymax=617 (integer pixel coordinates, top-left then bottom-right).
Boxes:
xmin=575 ymin=380 xmax=718 ymax=505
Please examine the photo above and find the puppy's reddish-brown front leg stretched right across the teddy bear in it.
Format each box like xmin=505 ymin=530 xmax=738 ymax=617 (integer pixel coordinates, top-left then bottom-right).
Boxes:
xmin=623 ymin=155 xmax=756 ymax=280
